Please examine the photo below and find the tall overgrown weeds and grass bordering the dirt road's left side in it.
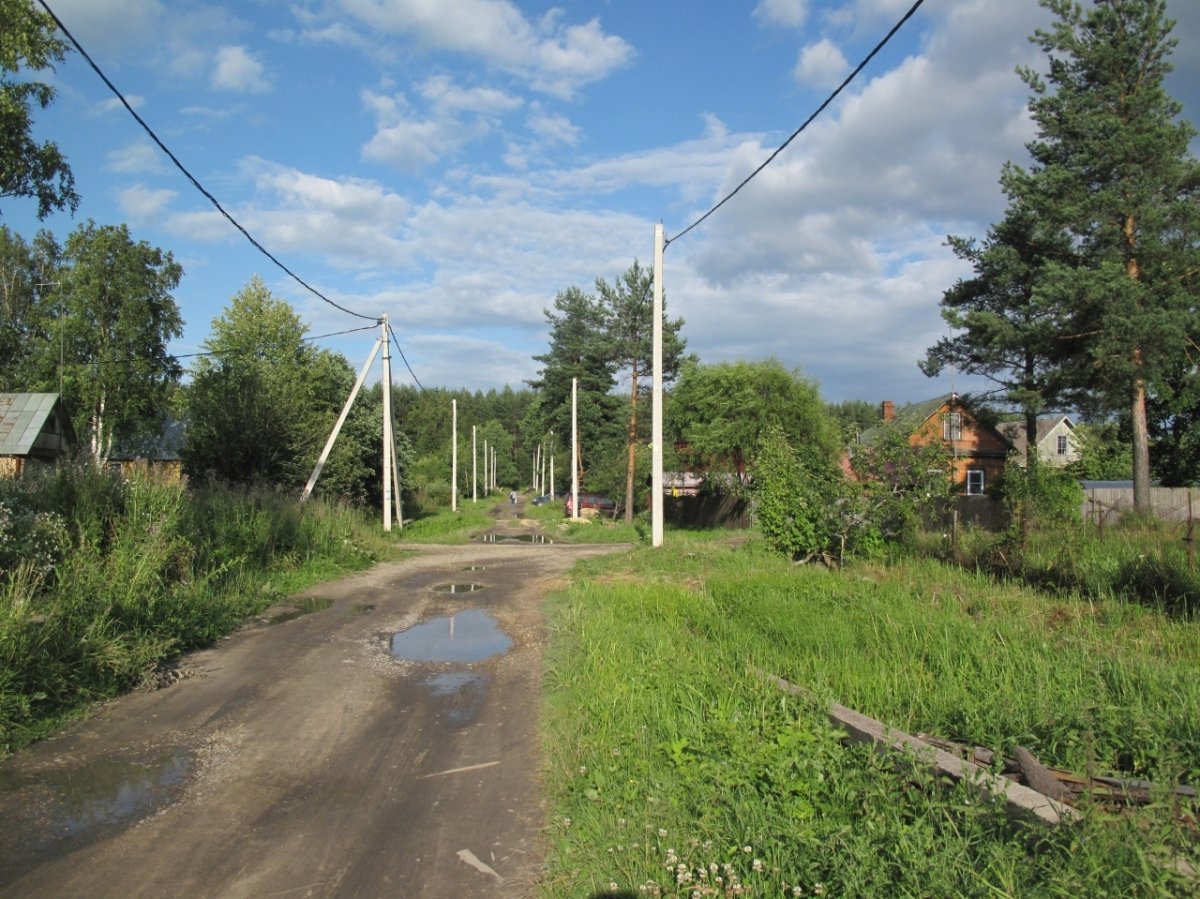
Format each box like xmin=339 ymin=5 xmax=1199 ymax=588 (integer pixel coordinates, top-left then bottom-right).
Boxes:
xmin=0 ymin=465 xmax=403 ymax=754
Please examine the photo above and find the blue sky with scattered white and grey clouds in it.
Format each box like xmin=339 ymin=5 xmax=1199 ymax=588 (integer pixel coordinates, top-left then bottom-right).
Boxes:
xmin=9 ymin=0 xmax=1200 ymax=403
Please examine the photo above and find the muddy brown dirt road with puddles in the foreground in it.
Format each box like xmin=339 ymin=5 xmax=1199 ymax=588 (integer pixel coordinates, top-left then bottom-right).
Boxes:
xmin=0 ymin=505 xmax=619 ymax=899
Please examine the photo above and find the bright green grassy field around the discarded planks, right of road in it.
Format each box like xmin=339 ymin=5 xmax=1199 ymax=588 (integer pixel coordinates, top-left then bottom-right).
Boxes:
xmin=544 ymin=534 xmax=1200 ymax=898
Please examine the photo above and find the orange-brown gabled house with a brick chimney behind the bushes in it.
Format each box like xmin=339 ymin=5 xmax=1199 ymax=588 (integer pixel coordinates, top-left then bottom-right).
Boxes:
xmin=850 ymin=394 xmax=1013 ymax=496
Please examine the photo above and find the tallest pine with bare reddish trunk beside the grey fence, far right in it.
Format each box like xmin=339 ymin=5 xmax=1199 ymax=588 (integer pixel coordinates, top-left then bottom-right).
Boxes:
xmin=1002 ymin=0 xmax=1200 ymax=510
